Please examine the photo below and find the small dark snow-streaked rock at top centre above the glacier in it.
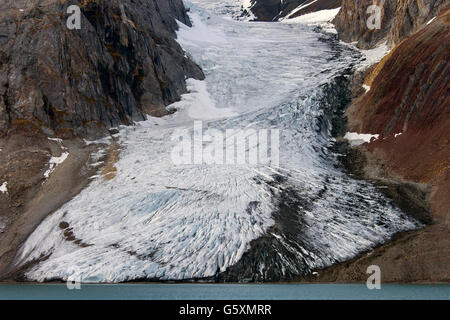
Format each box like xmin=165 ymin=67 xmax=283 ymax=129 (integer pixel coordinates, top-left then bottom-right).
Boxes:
xmin=246 ymin=0 xmax=342 ymax=21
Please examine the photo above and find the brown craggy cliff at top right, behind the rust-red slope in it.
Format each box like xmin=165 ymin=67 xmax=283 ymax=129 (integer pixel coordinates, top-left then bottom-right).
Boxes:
xmin=334 ymin=0 xmax=449 ymax=49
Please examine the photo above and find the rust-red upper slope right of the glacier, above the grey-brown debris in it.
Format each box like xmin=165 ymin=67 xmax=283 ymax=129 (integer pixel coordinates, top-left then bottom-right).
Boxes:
xmin=347 ymin=10 xmax=450 ymax=222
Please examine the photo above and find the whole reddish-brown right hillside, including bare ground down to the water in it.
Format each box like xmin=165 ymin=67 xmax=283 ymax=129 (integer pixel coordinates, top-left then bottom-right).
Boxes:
xmin=309 ymin=5 xmax=450 ymax=283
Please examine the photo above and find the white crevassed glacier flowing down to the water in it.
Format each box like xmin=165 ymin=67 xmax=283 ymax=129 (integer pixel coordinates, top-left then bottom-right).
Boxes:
xmin=16 ymin=0 xmax=419 ymax=282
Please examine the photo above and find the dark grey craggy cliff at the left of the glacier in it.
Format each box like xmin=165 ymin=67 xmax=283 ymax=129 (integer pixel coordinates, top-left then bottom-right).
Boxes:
xmin=0 ymin=0 xmax=203 ymax=137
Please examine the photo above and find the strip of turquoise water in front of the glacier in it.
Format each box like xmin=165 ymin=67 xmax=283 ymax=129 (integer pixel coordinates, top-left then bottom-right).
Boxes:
xmin=0 ymin=284 xmax=450 ymax=300
